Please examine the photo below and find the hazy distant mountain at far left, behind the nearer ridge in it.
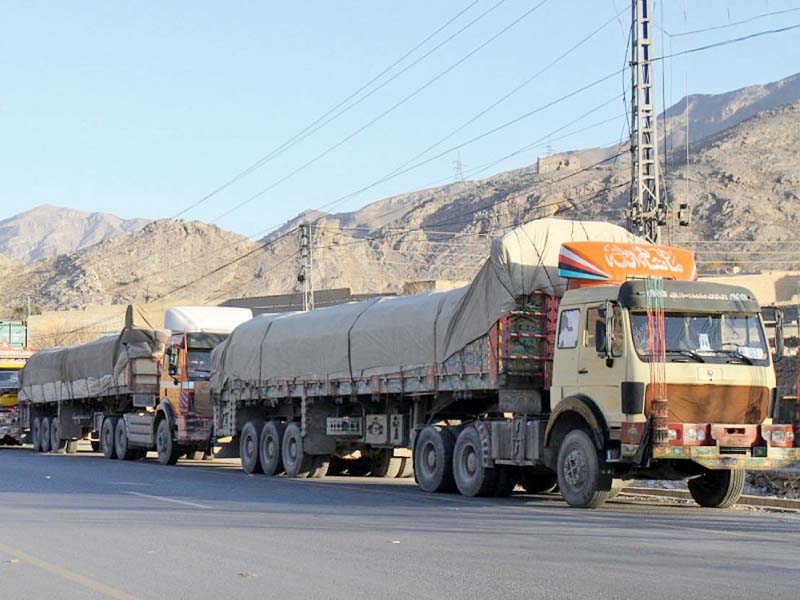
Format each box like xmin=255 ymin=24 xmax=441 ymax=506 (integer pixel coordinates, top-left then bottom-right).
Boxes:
xmin=0 ymin=204 xmax=149 ymax=263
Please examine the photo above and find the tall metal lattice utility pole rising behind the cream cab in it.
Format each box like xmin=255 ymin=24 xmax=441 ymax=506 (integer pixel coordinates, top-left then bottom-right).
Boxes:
xmin=627 ymin=0 xmax=667 ymax=243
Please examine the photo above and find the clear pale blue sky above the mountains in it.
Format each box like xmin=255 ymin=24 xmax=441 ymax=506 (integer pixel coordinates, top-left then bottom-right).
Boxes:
xmin=0 ymin=0 xmax=800 ymax=237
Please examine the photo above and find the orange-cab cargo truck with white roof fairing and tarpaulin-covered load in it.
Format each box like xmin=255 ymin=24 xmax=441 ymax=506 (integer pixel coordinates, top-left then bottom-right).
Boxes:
xmin=20 ymin=307 xmax=252 ymax=464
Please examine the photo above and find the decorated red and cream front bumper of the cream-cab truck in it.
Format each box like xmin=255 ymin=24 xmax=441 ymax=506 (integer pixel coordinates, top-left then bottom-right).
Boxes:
xmin=621 ymin=423 xmax=800 ymax=471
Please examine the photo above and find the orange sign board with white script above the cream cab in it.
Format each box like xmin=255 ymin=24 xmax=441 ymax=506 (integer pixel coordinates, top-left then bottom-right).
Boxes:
xmin=558 ymin=242 xmax=697 ymax=288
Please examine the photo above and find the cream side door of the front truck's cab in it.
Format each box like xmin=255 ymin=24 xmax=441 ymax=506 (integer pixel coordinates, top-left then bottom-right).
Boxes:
xmin=577 ymin=304 xmax=625 ymax=426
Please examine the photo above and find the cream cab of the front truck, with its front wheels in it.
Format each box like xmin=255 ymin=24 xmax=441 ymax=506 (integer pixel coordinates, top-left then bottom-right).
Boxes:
xmin=545 ymin=242 xmax=800 ymax=506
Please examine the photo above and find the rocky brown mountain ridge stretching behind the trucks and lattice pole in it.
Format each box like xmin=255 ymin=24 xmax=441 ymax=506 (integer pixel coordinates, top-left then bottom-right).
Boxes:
xmin=0 ymin=78 xmax=800 ymax=315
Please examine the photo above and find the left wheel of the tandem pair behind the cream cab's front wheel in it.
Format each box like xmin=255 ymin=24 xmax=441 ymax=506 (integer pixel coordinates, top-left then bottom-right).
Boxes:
xmin=414 ymin=425 xmax=456 ymax=493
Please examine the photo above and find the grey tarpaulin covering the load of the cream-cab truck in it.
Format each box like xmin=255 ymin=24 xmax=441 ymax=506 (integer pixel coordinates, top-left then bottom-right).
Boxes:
xmin=211 ymin=219 xmax=642 ymax=393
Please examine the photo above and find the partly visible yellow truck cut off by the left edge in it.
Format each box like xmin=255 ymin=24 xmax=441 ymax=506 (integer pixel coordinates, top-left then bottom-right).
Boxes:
xmin=0 ymin=321 xmax=33 ymax=445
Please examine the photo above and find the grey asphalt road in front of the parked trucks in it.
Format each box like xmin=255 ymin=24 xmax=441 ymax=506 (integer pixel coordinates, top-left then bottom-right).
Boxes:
xmin=0 ymin=448 xmax=800 ymax=600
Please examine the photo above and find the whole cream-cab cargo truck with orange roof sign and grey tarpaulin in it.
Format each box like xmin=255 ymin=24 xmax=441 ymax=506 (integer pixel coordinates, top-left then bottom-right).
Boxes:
xmin=211 ymin=219 xmax=800 ymax=507
